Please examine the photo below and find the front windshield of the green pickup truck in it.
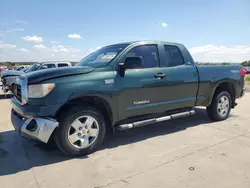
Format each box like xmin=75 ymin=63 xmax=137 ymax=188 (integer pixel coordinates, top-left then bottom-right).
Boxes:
xmin=76 ymin=44 xmax=128 ymax=67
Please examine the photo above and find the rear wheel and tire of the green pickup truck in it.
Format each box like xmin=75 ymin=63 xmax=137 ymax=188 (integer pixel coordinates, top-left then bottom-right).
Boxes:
xmin=207 ymin=91 xmax=232 ymax=121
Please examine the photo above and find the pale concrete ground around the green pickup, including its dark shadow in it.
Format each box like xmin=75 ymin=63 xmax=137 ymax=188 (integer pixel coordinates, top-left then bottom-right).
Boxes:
xmin=0 ymin=88 xmax=250 ymax=188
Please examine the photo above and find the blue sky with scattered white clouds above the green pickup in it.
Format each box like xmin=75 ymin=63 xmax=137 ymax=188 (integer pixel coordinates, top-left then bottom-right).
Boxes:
xmin=0 ymin=0 xmax=250 ymax=62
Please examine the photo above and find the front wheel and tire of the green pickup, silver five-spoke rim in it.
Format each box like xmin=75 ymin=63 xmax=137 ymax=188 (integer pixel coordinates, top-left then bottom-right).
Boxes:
xmin=55 ymin=106 xmax=106 ymax=157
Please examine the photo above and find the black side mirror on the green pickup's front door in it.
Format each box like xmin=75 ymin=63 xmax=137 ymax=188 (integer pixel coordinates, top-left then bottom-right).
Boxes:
xmin=119 ymin=56 xmax=143 ymax=77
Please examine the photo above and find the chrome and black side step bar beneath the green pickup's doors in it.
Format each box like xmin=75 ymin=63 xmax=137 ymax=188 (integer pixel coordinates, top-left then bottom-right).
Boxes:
xmin=117 ymin=110 xmax=195 ymax=130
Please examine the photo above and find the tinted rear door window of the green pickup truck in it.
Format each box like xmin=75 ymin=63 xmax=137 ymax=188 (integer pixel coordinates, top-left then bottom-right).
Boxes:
xmin=162 ymin=45 xmax=184 ymax=67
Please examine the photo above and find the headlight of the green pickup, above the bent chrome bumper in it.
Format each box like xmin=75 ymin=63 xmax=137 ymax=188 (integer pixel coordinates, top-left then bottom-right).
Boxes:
xmin=29 ymin=83 xmax=55 ymax=98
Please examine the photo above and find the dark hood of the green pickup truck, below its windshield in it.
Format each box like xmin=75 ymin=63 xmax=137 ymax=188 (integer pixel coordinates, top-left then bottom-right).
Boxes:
xmin=25 ymin=66 xmax=95 ymax=84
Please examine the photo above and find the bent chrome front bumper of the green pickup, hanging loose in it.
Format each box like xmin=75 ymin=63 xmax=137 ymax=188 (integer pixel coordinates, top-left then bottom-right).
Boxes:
xmin=11 ymin=109 xmax=59 ymax=143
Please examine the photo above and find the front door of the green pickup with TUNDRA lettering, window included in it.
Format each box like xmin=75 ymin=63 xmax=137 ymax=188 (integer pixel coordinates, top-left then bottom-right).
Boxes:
xmin=115 ymin=44 xmax=168 ymax=120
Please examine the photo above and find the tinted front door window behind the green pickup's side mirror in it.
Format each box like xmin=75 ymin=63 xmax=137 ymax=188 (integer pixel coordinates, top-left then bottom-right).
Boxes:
xmin=126 ymin=45 xmax=159 ymax=68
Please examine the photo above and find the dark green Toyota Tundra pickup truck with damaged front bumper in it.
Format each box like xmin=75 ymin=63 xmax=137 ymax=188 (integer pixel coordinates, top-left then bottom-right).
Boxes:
xmin=11 ymin=41 xmax=246 ymax=156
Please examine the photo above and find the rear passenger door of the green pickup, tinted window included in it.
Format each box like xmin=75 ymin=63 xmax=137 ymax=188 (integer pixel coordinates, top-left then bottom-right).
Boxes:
xmin=160 ymin=45 xmax=198 ymax=110
